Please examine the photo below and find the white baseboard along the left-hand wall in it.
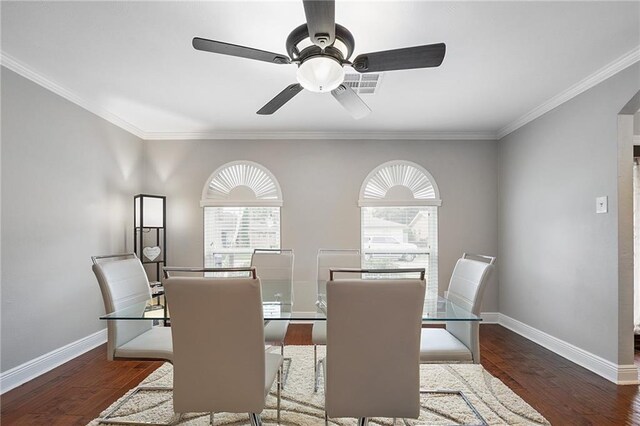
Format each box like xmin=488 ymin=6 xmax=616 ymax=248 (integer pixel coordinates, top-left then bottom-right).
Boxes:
xmin=0 ymin=328 xmax=107 ymax=394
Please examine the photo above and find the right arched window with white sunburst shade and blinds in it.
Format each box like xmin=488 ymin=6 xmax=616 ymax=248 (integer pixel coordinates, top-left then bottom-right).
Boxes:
xmin=358 ymin=161 xmax=442 ymax=291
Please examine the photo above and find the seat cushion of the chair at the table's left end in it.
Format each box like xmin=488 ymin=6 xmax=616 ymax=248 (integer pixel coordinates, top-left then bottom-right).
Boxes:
xmin=115 ymin=327 xmax=173 ymax=361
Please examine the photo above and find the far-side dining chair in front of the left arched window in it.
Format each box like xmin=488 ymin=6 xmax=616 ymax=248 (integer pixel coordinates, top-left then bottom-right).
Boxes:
xmin=251 ymin=249 xmax=294 ymax=364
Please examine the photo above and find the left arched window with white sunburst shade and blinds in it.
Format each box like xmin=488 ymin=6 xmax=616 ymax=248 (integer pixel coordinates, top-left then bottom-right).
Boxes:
xmin=200 ymin=161 xmax=282 ymax=267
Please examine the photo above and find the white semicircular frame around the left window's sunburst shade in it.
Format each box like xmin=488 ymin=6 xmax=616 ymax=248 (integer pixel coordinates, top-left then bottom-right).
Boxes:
xmin=200 ymin=160 xmax=283 ymax=207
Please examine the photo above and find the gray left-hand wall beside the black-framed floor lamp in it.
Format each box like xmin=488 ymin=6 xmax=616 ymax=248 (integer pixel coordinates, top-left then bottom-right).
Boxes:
xmin=0 ymin=68 xmax=142 ymax=372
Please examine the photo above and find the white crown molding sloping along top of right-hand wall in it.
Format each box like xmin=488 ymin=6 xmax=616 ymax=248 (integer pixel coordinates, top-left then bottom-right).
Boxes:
xmin=496 ymin=46 xmax=640 ymax=139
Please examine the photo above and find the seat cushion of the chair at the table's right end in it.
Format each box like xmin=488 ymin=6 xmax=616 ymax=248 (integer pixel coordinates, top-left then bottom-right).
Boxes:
xmin=420 ymin=328 xmax=473 ymax=363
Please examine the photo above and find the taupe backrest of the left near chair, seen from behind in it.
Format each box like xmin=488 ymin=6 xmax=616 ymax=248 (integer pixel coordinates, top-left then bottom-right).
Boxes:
xmin=164 ymin=277 xmax=265 ymax=413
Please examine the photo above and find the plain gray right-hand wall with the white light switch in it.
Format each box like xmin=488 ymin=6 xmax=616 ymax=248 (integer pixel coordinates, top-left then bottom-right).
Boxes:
xmin=499 ymin=64 xmax=640 ymax=364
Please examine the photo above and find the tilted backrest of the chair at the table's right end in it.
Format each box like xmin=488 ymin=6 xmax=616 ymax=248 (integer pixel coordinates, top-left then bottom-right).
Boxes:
xmin=446 ymin=253 xmax=496 ymax=363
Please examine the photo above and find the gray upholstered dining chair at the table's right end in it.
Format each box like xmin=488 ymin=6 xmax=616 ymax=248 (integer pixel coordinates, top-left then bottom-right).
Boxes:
xmin=420 ymin=253 xmax=496 ymax=364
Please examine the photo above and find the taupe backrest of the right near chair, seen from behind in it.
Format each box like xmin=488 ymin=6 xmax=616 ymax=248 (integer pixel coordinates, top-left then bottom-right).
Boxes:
xmin=325 ymin=279 xmax=426 ymax=418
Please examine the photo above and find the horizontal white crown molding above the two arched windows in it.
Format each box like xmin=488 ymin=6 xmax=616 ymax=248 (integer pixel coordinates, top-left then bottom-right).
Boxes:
xmin=143 ymin=132 xmax=496 ymax=140
